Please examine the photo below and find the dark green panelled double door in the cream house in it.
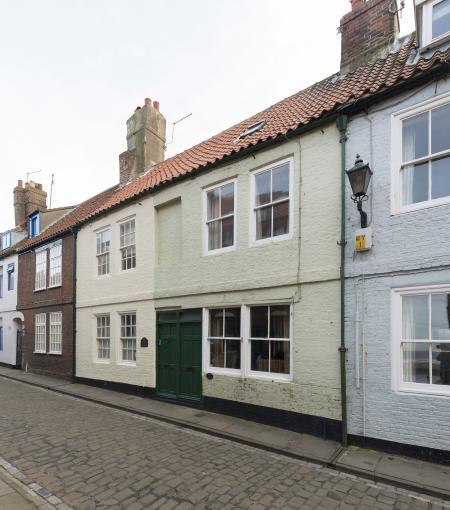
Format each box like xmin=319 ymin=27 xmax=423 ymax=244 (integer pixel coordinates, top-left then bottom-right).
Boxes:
xmin=156 ymin=309 xmax=202 ymax=400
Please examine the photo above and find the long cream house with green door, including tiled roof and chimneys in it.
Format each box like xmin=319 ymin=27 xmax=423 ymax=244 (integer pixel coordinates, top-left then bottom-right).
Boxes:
xmin=76 ymin=0 xmax=449 ymax=438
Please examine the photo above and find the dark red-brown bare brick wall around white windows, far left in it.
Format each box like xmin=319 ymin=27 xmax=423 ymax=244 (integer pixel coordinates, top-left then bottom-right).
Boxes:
xmin=17 ymin=234 xmax=73 ymax=378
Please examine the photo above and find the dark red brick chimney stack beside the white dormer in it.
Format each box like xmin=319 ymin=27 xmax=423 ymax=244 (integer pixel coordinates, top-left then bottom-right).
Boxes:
xmin=339 ymin=0 xmax=399 ymax=74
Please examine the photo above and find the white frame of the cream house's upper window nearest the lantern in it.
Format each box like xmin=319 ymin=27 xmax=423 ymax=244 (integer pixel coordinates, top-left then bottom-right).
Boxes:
xmin=249 ymin=156 xmax=294 ymax=246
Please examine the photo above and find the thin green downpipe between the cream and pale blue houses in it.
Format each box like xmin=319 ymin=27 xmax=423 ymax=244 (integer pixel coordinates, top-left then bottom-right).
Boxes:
xmin=336 ymin=115 xmax=348 ymax=447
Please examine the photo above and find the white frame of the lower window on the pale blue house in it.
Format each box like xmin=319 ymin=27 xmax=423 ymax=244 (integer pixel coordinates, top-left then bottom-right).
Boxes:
xmin=391 ymin=285 xmax=450 ymax=395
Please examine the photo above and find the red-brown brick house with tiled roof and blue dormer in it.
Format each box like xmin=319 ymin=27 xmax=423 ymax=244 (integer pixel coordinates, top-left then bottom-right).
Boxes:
xmin=15 ymin=186 xmax=117 ymax=379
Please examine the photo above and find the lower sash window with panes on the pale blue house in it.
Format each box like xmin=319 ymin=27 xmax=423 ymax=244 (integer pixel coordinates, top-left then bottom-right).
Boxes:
xmin=393 ymin=288 xmax=450 ymax=393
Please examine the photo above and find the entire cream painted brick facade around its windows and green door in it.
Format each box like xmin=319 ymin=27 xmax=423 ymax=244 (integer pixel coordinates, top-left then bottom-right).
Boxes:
xmin=77 ymin=124 xmax=340 ymax=419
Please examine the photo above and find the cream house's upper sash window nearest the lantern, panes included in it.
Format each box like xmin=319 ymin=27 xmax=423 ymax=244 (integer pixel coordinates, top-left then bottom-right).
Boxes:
xmin=252 ymin=159 xmax=292 ymax=242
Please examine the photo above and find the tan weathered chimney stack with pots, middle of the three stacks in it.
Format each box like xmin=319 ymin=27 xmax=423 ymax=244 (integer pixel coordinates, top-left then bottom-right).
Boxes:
xmin=119 ymin=97 xmax=166 ymax=186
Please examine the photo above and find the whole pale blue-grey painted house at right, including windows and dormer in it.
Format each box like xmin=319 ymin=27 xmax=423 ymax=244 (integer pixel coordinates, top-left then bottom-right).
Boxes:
xmin=345 ymin=0 xmax=450 ymax=462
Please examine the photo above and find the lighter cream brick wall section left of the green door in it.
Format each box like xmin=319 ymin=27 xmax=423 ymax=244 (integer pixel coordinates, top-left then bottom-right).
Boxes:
xmin=76 ymin=197 xmax=155 ymax=387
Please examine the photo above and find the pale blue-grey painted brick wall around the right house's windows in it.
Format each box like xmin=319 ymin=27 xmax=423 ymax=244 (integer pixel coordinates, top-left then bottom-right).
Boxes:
xmin=346 ymin=79 xmax=450 ymax=450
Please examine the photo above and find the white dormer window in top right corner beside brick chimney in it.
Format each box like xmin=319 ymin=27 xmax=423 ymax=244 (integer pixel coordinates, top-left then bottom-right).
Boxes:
xmin=416 ymin=0 xmax=450 ymax=49
